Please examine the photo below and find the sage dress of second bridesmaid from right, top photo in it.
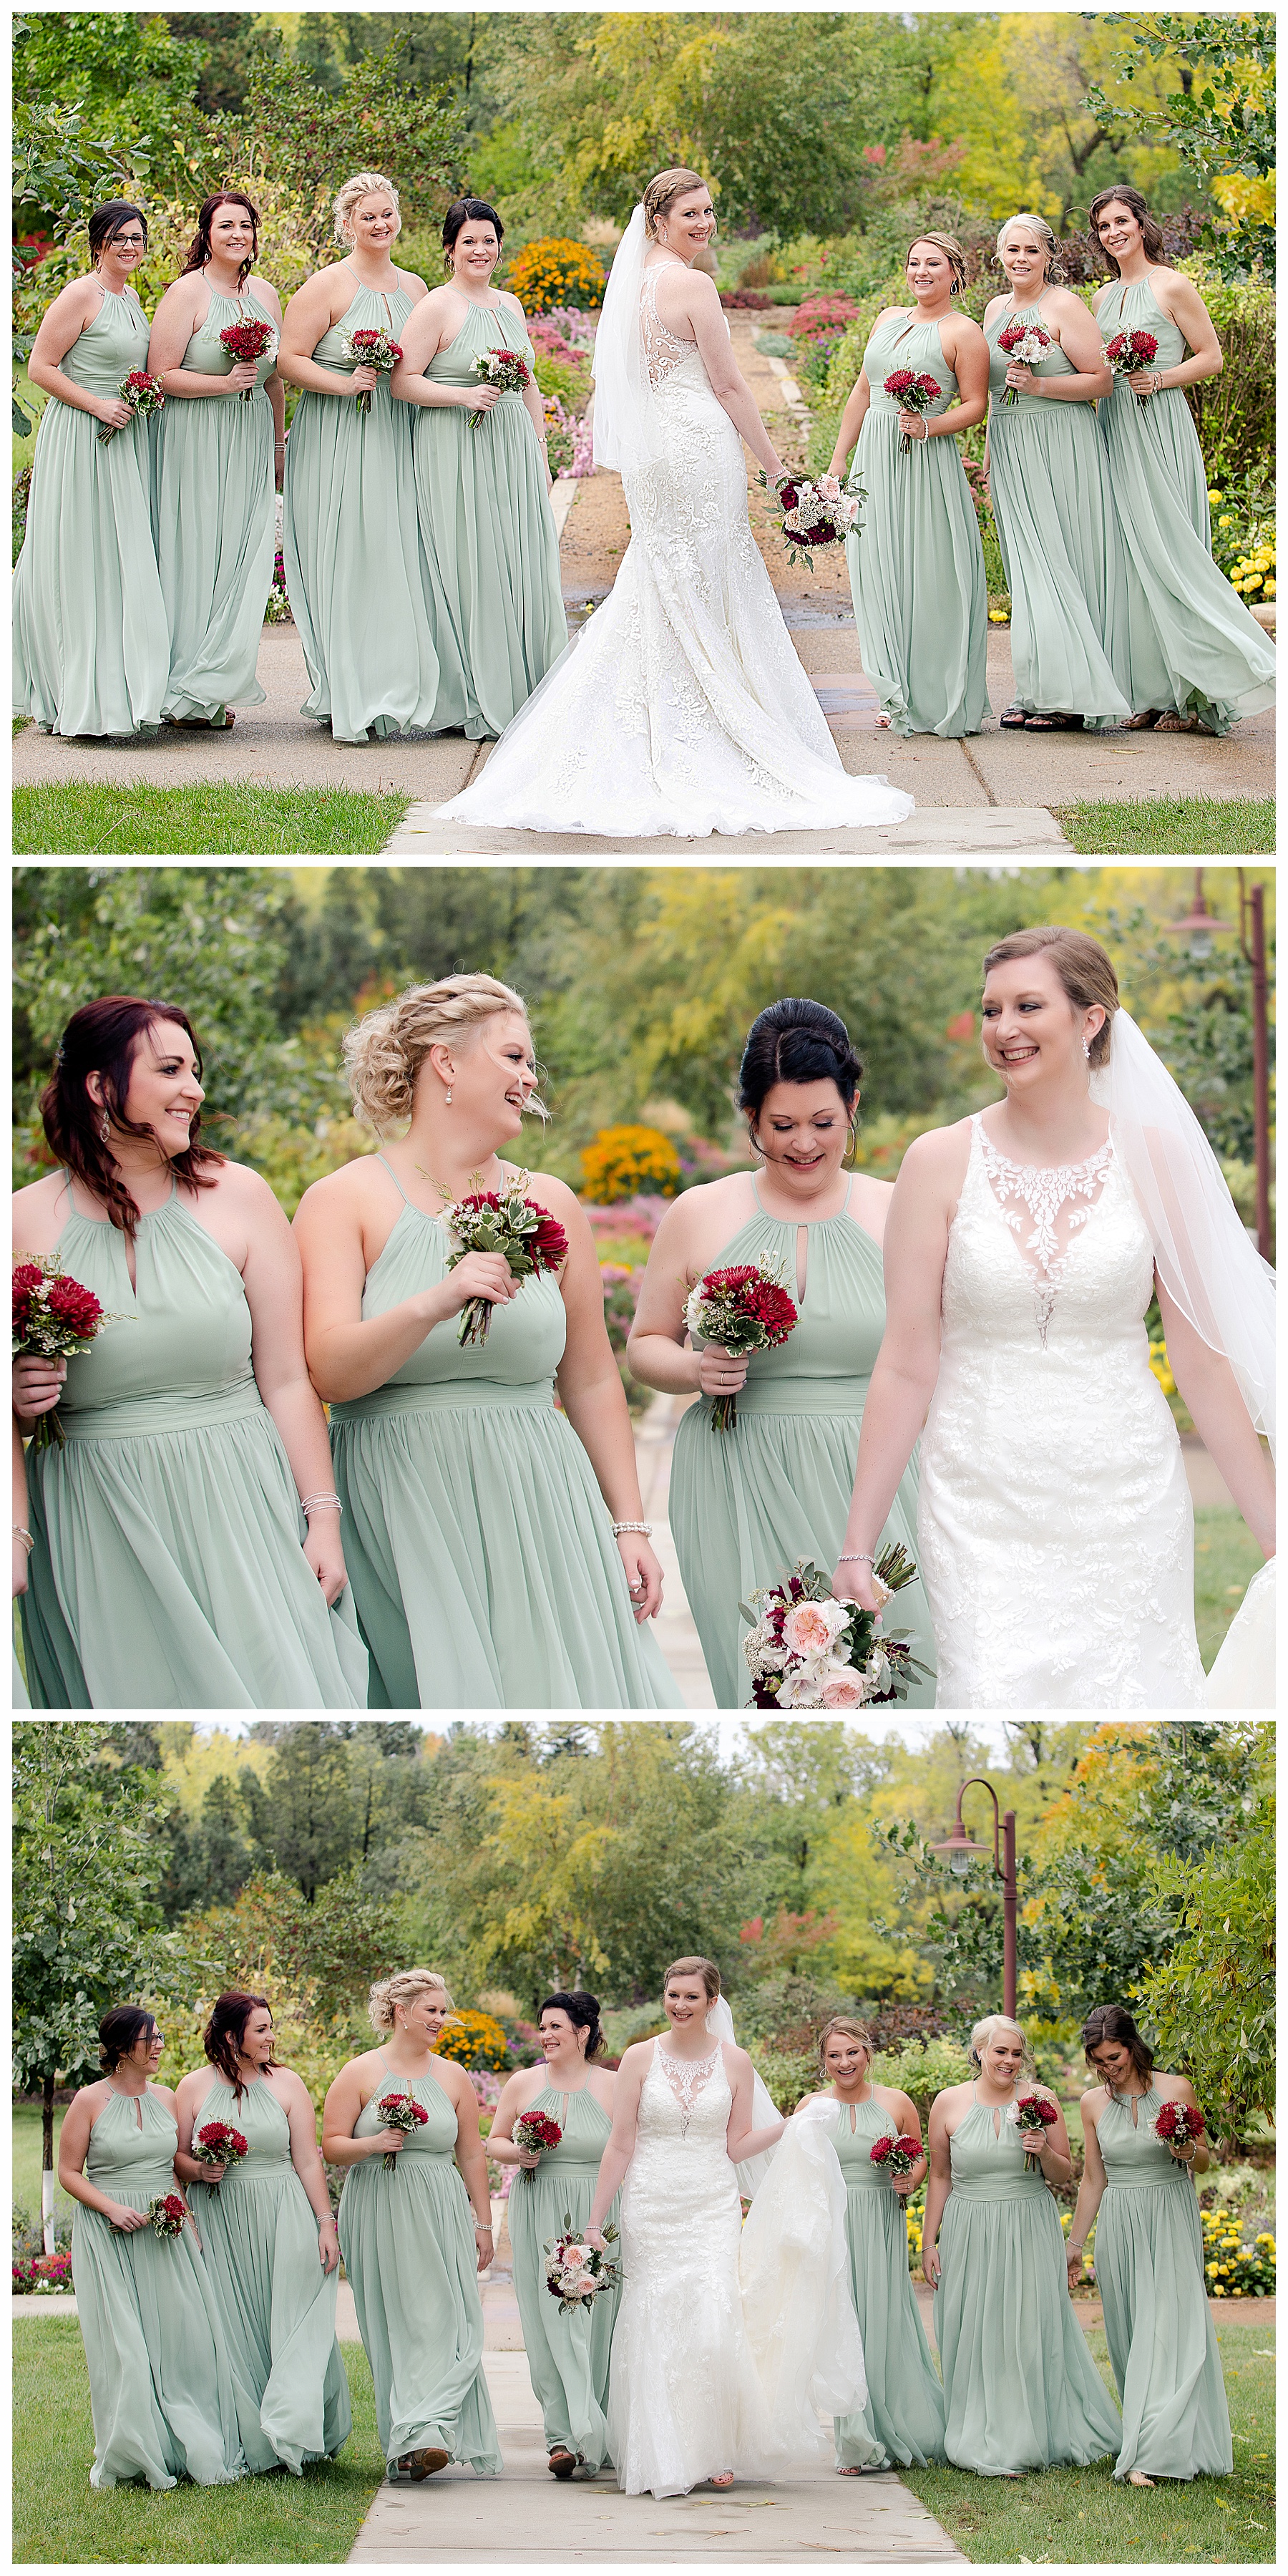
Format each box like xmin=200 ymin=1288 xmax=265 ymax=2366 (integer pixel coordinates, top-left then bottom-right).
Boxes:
xmin=984 ymin=306 xmax=1131 ymax=729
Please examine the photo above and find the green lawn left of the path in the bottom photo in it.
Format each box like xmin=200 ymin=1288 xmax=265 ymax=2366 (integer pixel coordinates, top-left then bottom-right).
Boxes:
xmin=13 ymin=2316 xmax=384 ymax=2566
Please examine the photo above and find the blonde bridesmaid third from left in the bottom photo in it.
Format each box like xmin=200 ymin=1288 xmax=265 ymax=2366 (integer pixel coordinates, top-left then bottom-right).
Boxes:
xmin=322 ymin=1968 xmax=499 ymax=2483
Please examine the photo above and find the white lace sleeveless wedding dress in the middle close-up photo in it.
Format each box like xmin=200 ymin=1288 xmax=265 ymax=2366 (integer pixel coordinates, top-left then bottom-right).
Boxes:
xmin=917 ymin=1115 xmax=1206 ymax=1708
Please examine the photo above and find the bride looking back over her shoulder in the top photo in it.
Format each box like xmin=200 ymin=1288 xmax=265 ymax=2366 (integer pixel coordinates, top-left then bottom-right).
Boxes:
xmin=438 ymin=170 xmax=912 ymax=837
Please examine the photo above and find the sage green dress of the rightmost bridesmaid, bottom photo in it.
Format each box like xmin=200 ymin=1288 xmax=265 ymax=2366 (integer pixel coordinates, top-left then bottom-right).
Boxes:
xmin=1095 ymin=2084 xmax=1234 ymax=2478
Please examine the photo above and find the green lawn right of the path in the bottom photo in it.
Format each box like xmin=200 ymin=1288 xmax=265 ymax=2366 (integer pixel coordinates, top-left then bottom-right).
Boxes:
xmin=902 ymin=2321 xmax=1275 ymax=2566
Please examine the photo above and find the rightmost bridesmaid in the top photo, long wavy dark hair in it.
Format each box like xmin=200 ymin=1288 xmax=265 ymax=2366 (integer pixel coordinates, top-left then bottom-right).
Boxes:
xmin=1087 ymin=188 xmax=1275 ymax=734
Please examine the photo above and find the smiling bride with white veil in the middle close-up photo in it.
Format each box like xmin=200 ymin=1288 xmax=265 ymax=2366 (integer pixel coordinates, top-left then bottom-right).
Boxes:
xmin=834 ymin=930 xmax=1275 ymax=1708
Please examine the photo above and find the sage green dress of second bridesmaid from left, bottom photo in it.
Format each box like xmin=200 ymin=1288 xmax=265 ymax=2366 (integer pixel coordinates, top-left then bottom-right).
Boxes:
xmin=188 ymin=2076 xmax=351 ymax=2478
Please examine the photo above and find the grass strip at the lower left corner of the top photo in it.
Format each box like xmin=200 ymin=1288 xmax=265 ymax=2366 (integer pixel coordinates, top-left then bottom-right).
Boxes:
xmin=13 ymin=778 xmax=412 ymax=857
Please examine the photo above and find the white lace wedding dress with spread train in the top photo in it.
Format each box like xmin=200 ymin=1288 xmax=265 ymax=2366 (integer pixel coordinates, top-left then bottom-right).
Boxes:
xmin=438 ymin=266 xmax=912 ymax=840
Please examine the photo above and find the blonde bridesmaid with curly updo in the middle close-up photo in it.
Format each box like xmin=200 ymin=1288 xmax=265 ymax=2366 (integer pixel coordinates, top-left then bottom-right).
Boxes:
xmin=296 ymin=973 xmax=680 ymax=1708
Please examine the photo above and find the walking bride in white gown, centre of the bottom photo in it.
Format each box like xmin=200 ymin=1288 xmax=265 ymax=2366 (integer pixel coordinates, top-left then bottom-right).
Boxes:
xmin=587 ymin=1958 xmax=866 ymax=2496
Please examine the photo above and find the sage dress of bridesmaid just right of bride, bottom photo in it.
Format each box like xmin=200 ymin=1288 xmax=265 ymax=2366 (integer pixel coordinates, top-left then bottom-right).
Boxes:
xmin=832 ymin=2102 xmax=943 ymax=2468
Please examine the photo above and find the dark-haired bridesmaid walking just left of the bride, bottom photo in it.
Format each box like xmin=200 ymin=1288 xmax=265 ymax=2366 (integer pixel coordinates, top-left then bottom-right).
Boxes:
xmin=487 ymin=1994 xmax=621 ymax=2478
